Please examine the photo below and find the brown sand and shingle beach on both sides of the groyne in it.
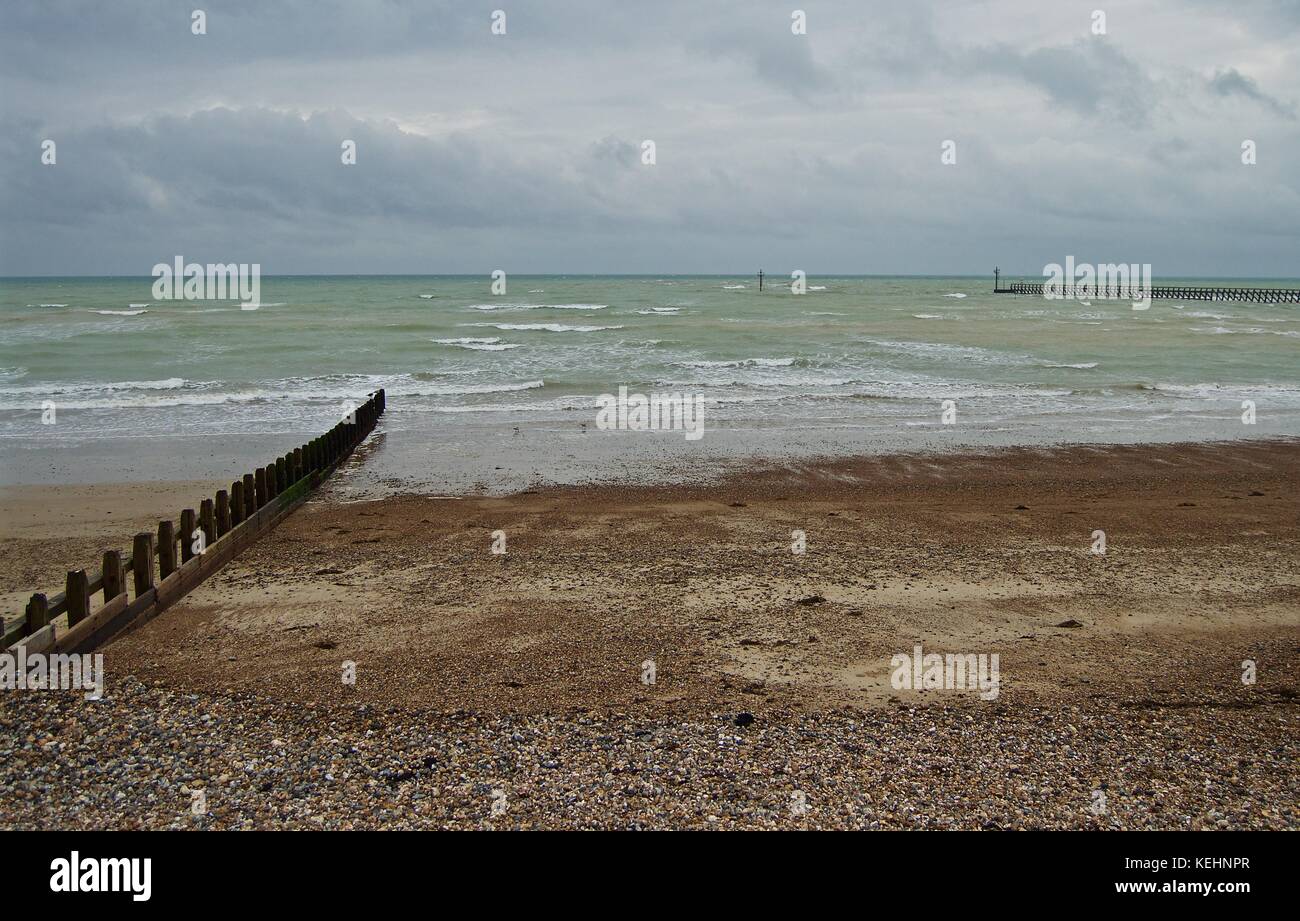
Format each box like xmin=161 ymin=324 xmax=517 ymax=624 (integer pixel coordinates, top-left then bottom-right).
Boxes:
xmin=0 ymin=441 xmax=1300 ymax=829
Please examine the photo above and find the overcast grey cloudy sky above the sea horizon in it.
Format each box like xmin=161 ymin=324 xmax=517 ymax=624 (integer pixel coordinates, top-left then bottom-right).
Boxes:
xmin=0 ymin=0 xmax=1300 ymax=278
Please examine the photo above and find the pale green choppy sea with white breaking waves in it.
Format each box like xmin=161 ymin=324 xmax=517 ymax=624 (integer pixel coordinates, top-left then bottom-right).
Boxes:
xmin=0 ymin=274 xmax=1300 ymax=494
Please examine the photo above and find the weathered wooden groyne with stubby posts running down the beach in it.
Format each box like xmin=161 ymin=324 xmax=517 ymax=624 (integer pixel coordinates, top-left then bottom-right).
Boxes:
xmin=0 ymin=390 xmax=385 ymax=653
